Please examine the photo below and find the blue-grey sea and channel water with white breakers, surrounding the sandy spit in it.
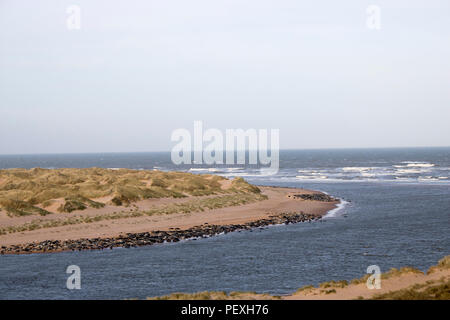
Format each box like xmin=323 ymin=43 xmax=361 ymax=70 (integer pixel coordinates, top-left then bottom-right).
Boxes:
xmin=0 ymin=148 xmax=450 ymax=299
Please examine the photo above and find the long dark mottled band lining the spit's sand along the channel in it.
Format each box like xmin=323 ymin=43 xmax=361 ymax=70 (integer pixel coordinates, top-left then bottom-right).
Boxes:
xmin=0 ymin=212 xmax=321 ymax=255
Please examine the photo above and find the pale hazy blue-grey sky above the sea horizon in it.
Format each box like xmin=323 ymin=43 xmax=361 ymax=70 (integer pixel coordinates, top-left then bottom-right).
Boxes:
xmin=0 ymin=0 xmax=450 ymax=154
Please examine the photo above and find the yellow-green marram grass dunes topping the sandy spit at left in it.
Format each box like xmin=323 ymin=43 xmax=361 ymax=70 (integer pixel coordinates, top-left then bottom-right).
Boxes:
xmin=0 ymin=168 xmax=260 ymax=216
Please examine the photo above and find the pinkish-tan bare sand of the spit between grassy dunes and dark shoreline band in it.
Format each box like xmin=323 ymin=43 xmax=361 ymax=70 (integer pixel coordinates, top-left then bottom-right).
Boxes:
xmin=0 ymin=187 xmax=338 ymax=252
